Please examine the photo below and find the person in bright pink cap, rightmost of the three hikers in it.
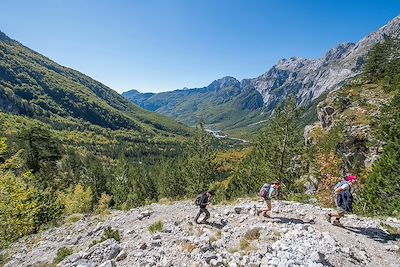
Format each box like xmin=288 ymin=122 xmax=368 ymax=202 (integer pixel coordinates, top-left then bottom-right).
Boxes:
xmin=326 ymin=175 xmax=357 ymax=226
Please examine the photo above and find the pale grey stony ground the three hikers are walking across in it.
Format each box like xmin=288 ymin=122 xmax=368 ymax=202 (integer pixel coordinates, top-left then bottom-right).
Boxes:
xmin=1 ymin=200 xmax=400 ymax=267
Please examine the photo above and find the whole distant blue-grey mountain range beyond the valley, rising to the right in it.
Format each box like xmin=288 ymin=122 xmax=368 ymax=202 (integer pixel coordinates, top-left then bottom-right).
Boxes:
xmin=122 ymin=16 xmax=400 ymax=138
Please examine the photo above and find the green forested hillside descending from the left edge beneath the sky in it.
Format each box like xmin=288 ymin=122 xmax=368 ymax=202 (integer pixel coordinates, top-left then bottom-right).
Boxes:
xmin=0 ymin=32 xmax=188 ymax=134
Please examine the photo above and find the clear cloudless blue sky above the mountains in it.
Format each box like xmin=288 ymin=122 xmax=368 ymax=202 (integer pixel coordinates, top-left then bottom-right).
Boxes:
xmin=0 ymin=0 xmax=400 ymax=92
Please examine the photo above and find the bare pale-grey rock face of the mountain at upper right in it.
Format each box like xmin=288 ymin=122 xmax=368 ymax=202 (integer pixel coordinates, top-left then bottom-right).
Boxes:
xmin=251 ymin=16 xmax=400 ymax=109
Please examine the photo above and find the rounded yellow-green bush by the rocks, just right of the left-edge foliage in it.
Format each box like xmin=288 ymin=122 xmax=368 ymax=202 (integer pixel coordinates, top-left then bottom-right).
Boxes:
xmin=60 ymin=184 xmax=93 ymax=214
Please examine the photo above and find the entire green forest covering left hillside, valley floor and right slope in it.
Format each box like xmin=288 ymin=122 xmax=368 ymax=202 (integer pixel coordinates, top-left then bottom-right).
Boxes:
xmin=0 ymin=32 xmax=400 ymax=250
